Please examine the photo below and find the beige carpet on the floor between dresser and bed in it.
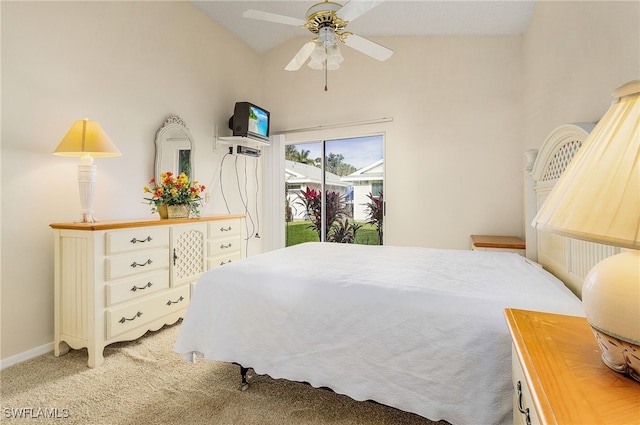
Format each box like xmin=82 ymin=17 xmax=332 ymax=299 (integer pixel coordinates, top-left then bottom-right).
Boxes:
xmin=0 ymin=324 xmax=446 ymax=425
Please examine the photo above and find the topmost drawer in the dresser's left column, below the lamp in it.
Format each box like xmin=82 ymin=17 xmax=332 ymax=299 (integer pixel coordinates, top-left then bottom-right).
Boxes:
xmin=105 ymin=227 xmax=169 ymax=255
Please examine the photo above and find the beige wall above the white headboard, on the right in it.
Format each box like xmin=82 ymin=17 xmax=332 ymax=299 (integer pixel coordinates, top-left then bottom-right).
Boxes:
xmin=522 ymin=1 xmax=640 ymax=151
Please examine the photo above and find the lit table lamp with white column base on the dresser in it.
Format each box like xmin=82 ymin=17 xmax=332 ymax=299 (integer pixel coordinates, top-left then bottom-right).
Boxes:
xmin=53 ymin=119 xmax=121 ymax=223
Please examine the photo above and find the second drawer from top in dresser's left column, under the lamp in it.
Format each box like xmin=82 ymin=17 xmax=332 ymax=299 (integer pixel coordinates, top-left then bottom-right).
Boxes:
xmin=105 ymin=248 xmax=169 ymax=280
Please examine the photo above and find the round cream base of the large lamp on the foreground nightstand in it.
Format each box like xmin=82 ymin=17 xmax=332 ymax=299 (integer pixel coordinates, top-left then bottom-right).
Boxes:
xmin=582 ymin=250 xmax=640 ymax=382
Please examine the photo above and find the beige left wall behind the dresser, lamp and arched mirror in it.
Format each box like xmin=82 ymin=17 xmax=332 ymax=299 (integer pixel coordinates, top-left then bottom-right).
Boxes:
xmin=1 ymin=1 xmax=262 ymax=359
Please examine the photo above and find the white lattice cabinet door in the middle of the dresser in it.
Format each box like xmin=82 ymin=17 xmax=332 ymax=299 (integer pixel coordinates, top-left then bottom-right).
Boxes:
xmin=171 ymin=223 xmax=207 ymax=286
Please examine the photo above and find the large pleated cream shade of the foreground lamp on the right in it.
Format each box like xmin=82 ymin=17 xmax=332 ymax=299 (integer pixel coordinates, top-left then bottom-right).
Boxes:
xmin=532 ymin=80 xmax=640 ymax=249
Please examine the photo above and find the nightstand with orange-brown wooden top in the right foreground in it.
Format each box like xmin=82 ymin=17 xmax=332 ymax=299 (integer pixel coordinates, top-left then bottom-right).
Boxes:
xmin=505 ymin=309 xmax=640 ymax=425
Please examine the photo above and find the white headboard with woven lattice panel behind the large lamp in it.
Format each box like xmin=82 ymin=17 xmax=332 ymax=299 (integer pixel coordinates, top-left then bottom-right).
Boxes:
xmin=525 ymin=123 xmax=620 ymax=298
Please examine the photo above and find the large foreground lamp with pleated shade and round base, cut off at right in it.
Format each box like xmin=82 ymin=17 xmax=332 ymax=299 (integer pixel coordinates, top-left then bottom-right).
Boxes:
xmin=533 ymin=80 xmax=640 ymax=381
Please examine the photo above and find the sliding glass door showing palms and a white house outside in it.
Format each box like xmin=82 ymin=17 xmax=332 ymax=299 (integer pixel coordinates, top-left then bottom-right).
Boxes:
xmin=285 ymin=135 xmax=384 ymax=246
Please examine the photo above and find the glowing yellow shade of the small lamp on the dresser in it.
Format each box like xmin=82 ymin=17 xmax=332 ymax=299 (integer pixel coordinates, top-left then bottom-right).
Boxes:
xmin=53 ymin=119 xmax=121 ymax=157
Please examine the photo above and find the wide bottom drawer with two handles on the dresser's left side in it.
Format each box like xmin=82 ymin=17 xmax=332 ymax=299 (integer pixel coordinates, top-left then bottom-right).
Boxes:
xmin=105 ymin=285 xmax=189 ymax=339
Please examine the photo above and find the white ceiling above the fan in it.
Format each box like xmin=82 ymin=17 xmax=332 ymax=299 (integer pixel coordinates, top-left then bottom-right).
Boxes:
xmin=190 ymin=0 xmax=535 ymax=53
